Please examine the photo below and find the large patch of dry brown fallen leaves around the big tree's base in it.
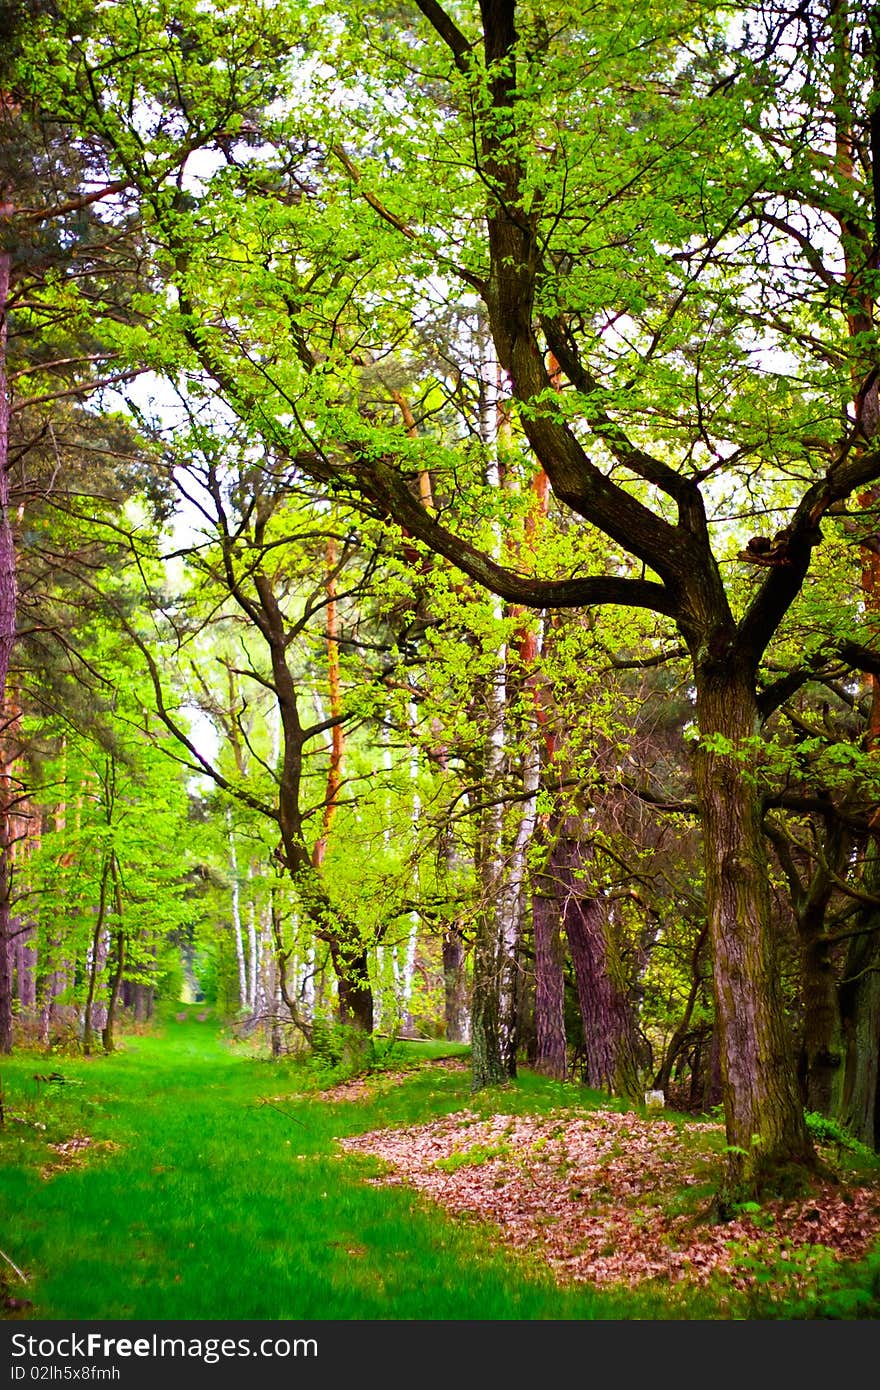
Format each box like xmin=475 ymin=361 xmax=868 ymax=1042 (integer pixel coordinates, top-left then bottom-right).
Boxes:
xmin=339 ymin=1111 xmax=880 ymax=1291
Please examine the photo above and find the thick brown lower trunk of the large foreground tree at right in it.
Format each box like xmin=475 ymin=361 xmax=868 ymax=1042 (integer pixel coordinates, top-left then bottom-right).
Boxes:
xmin=695 ymin=657 xmax=815 ymax=1194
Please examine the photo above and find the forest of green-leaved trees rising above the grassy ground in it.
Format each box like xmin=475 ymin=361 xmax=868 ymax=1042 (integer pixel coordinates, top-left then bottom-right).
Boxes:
xmin=0 ymin=0 xmax=880 ymax=1316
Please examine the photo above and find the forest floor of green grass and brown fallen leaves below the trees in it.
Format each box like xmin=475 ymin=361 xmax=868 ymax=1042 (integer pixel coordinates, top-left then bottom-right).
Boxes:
xmin=0 ymin=1009 xmax=880 ymax=1322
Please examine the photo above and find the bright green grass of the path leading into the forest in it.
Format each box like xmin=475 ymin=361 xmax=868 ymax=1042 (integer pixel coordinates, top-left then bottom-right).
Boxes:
xmin=0 ymin=1009 xmax=873 ymax=1321
